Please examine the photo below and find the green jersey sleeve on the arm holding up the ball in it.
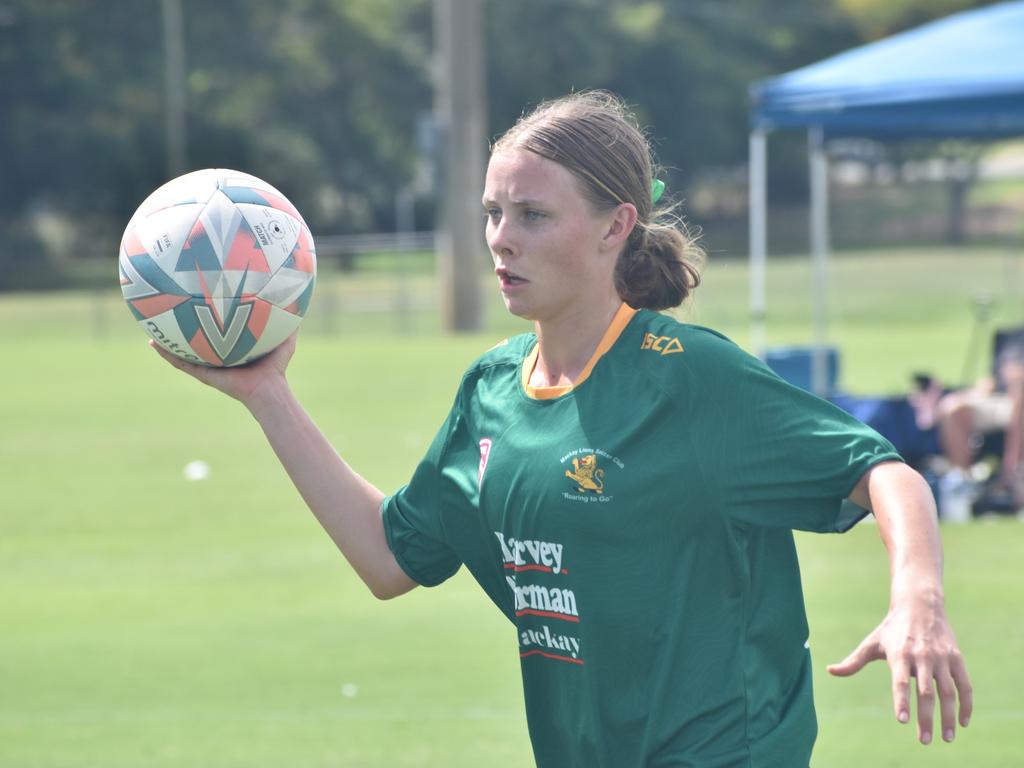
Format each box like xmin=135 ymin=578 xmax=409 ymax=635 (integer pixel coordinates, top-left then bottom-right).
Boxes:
xmin=381 ymin=399 xmax=462 ymax=587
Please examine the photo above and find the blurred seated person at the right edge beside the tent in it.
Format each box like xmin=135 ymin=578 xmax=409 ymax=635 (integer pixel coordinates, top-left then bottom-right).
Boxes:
xmin=935 ymin=331 xmax=1024 ymax=511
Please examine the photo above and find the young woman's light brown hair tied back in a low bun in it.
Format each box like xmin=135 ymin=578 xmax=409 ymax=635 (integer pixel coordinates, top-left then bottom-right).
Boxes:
xmin=490 ymin=91 xmax=703 ymax=309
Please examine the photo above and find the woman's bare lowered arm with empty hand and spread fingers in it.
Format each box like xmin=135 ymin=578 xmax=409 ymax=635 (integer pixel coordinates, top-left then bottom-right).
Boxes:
xmin=828 ymin=462 xmax=972 ymax=744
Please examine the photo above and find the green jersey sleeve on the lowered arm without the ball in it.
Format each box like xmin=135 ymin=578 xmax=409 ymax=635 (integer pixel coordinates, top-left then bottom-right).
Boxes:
xmin=702 ymin=341 xmax=902 ymax=532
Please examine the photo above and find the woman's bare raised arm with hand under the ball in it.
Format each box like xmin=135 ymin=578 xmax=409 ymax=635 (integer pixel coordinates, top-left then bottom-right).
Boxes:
xmin=151 ymin=336 xmax=417 ymax=600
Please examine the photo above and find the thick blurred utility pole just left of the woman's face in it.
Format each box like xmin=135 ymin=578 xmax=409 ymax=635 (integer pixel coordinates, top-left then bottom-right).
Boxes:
xmin=433 ymin=0 xmax=486 ymax=331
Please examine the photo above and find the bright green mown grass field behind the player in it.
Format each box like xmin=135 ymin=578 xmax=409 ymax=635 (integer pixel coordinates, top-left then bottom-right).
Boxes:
xmin=0 ymin=251 xmax=1024 ymax=768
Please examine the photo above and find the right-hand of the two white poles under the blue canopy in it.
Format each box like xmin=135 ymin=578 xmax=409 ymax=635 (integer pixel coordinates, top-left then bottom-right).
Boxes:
xmin=807 ymin=125 xmax=829 ymax=397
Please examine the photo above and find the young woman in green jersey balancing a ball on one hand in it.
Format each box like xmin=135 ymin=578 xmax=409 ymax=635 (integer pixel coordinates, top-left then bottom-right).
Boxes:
xmin=151 ymin=92 xmax=971 ymax=768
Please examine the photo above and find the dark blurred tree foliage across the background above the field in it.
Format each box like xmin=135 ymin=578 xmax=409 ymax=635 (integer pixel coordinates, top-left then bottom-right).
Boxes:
xmin=0 ymin=0 xmax=1007 ymax=287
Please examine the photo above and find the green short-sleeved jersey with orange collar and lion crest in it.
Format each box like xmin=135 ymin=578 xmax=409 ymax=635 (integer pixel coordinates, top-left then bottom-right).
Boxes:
xmin=383 ymin=306 xmax=899 ymax=768
